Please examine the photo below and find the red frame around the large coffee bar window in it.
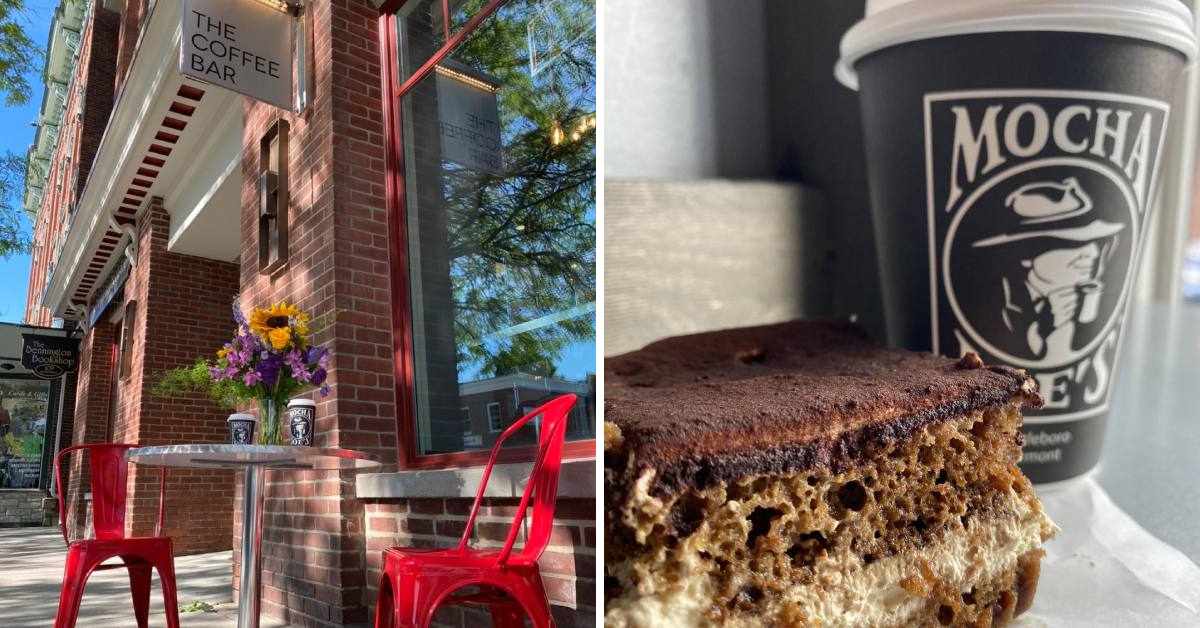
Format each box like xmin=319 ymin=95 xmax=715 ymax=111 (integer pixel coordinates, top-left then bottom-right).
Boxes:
xmin=379 ymin=0 xmax=596 ymax=468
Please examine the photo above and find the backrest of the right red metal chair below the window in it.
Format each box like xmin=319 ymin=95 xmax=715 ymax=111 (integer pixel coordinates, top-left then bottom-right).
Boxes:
xmin=458 ymin=395 xmax=576 ymax=564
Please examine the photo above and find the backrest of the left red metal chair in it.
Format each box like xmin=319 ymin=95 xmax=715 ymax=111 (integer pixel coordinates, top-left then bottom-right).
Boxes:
xmin=54 ymin=443 xmax=166 ymax=545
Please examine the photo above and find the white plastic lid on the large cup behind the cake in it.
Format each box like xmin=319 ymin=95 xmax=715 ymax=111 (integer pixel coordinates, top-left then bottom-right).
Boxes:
xmin=834 ymin=0 xmax=1196 ymax=89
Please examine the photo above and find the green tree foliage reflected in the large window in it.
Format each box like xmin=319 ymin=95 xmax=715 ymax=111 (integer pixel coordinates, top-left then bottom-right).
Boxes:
xmin=443 ymin=0 xmax=596 ymax=375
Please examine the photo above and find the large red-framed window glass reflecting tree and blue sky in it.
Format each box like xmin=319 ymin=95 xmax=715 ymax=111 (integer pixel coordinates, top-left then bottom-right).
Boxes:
xmin=396 ymin=0 xmax=595 ymax=455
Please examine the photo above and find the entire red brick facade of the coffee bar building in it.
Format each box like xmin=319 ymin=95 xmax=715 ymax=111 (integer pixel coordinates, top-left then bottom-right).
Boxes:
xmin=31 ymin=0 xmax=596 ymax=627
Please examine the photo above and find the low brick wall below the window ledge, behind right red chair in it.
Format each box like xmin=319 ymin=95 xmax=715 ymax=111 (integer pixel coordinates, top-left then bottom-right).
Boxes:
xmin=366 ymin=498 xmax=596 ymax=628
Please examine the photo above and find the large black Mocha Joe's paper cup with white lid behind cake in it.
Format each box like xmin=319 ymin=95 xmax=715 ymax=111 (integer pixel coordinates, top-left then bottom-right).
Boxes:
xmin=836 ymin=0 xmax=1195 ymax=483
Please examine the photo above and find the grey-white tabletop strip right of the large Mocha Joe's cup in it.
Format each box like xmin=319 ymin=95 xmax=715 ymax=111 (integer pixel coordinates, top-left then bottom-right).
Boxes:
xmin=1094 ymin=304 xmax=1200 ymax=562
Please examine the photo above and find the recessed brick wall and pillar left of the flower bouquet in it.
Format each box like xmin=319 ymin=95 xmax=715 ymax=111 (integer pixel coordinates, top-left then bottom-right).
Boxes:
xmin=58 ymin=199 xmax=238 ymax=554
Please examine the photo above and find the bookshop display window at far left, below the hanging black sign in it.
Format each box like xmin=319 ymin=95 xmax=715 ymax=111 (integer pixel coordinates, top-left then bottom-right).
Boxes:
xmin=0 ymin=378 xmax=50 ymax=489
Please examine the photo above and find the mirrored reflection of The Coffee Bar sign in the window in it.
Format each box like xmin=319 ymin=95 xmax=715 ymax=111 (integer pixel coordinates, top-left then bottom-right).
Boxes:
xmin=437 ymin=72 xmax=504 ymax=174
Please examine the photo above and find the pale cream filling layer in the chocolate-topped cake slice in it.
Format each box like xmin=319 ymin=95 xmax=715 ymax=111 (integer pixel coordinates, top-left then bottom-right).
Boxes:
xmin=605 ymin=494 xmax=1055 ymax=628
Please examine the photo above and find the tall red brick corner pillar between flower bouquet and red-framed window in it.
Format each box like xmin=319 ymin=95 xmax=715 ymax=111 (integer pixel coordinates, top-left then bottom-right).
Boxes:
xmin=234 ymin=0 xmax=396 ymax=626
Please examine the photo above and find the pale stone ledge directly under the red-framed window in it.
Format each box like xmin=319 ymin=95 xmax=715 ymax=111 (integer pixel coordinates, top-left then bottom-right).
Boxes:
xmin=355 ymin=457 xmax=596 ymax=500
